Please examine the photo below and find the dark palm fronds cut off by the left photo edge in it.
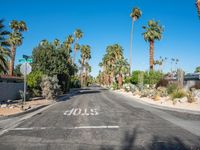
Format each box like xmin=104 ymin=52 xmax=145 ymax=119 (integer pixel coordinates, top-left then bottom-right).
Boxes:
xmin=0 ymin=20 xmax=10 ymax=73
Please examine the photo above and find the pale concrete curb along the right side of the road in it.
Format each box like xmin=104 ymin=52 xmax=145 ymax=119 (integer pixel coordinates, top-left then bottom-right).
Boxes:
xmin=109 ymin=89 xmax=200 ymax=115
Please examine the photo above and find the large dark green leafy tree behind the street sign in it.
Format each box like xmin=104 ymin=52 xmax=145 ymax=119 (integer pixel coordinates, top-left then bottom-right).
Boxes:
xmin=32 ymin=39 xmax=77 ymax=92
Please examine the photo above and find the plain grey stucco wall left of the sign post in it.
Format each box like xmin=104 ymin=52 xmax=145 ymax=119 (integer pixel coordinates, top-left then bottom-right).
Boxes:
xmin=0 ymin=82 xmax=23 ymax=101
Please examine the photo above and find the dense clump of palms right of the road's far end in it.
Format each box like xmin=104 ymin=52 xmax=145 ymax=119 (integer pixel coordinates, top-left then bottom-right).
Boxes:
xmin=98 ymin=44 xmax=130 ymax=88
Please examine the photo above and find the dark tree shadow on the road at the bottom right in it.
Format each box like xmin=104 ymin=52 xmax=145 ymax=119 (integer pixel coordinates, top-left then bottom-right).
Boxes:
xmin=79 ymin=127 xmax=200 ymax=150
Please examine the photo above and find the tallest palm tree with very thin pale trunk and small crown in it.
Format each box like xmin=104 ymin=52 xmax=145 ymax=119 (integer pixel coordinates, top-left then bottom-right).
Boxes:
xmin=130 ymin=8 xmax=142 ymax=73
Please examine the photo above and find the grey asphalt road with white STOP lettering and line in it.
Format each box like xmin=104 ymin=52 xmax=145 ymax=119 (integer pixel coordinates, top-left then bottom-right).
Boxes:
xmin=0 ymin=86 xmax=200 ymax=150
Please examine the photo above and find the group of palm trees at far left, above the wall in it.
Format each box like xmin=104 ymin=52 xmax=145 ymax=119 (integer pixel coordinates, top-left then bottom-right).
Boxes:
xmin=0 ymin=20 xmax=27 ymax=76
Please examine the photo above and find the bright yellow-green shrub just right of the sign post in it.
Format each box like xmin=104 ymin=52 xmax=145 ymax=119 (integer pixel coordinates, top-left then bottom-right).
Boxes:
xmin=27 ymin=71 xmax=43 ymax=97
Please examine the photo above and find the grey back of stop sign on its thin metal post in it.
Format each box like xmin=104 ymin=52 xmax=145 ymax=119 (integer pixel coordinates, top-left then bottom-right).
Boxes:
xmin=20 ymin=62 xmax=32 ymax=108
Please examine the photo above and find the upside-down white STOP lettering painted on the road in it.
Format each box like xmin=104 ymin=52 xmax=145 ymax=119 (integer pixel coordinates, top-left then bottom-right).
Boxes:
xmin=64 ymin=108 xmax=99 ymax=116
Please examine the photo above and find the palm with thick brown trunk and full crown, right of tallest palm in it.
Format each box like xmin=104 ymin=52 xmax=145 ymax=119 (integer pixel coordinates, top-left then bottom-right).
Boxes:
xmin=143 ymin=20 xmax=163 ymax=70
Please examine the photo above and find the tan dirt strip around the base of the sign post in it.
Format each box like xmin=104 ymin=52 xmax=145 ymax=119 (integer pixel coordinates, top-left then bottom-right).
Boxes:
xmin=0 ymin=99 xmax=52 ymax=116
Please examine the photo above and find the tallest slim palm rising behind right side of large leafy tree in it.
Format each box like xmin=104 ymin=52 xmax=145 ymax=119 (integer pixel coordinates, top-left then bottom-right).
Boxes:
xmin=73 ymin=29 xmax=83 ymax=64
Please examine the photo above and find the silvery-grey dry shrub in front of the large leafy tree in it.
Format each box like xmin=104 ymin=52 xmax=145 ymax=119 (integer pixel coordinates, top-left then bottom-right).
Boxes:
xmin=41 ymin=75 xmax=60 ymax=100
